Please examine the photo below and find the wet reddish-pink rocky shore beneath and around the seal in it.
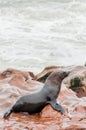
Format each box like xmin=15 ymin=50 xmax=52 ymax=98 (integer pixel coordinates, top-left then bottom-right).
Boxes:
xmin=0 ymin=66 xmax=86 ymax=130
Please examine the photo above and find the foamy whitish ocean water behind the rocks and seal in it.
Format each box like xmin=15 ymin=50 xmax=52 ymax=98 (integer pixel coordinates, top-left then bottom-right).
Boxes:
xmin=0 ymin=0 xmax=86 ymax=73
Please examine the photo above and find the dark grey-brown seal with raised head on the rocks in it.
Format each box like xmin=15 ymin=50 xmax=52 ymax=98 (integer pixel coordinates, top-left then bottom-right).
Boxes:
xmin=3 ymin=70 xmax=69 ymax=118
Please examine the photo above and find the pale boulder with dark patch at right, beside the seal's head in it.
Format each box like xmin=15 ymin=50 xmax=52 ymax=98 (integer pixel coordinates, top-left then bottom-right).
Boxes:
xmin=64 ymin=66 xmax=86 ymax=97
